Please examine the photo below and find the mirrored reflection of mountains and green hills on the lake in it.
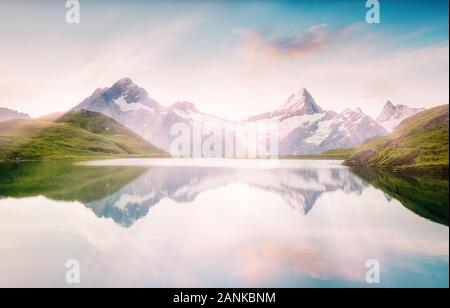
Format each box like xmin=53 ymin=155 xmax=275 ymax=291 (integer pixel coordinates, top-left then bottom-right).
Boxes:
xmin=0 ymin=162 xmax=448 ymax=228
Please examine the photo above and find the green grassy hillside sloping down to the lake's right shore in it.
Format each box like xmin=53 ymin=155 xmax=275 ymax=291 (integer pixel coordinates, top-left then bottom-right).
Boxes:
xmin=344 ymin=105 xmax=449 ymax=173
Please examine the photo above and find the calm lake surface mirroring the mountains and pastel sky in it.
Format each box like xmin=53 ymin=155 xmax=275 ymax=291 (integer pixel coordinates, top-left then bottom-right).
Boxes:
xmin=0 ymin=159 xmax=449 ymax=287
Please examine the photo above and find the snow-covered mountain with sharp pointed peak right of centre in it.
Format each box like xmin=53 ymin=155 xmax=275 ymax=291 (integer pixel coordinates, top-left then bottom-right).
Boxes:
xmin=248 ymin=89 xmax=387 ymax=155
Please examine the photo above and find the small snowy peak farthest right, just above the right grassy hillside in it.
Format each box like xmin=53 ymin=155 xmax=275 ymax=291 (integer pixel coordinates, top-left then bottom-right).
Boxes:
xmin=375 ymin=101 xmax=425 ymax=132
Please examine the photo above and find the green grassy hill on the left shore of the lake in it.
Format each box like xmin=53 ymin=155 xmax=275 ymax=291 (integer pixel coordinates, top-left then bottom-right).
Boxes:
xmin=0 ymin=110 xmax=165 ymax=160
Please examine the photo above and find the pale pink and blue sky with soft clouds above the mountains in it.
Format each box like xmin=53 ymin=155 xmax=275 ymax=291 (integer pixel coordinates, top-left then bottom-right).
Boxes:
xmin=0 ymin=0 xmax=449 ymax=119
